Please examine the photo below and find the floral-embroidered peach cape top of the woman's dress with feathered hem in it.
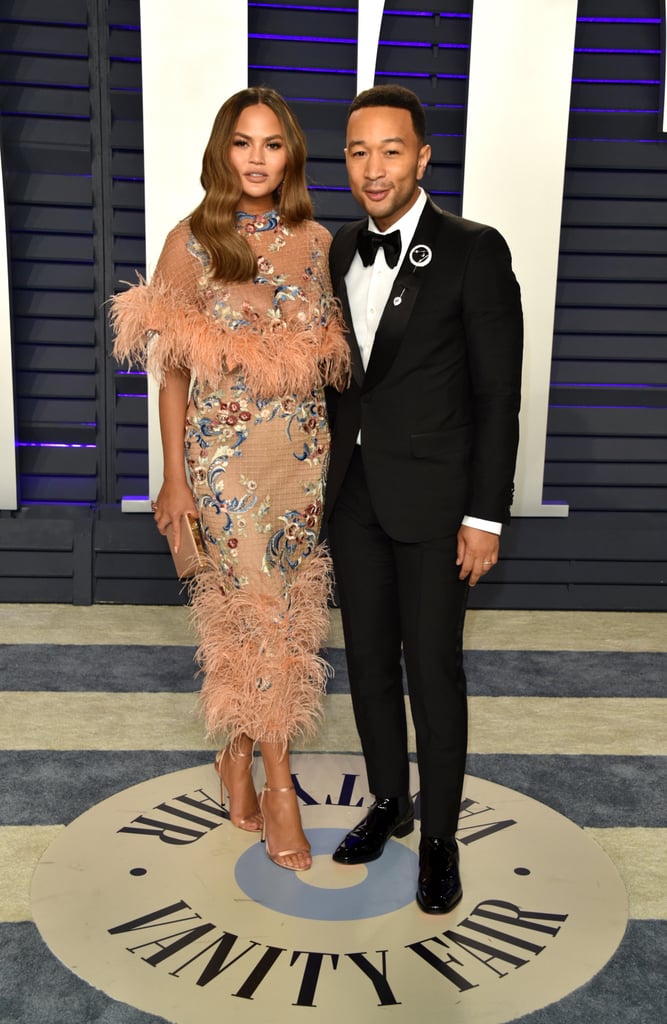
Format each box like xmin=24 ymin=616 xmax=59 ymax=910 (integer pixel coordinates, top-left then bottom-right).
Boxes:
xmin=112 ymin=211 xmax=349 ymax=395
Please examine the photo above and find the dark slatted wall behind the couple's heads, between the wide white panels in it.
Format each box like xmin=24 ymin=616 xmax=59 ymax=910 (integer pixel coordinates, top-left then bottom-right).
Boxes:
xmin=249 ymin=0 xmax=471 ymax=224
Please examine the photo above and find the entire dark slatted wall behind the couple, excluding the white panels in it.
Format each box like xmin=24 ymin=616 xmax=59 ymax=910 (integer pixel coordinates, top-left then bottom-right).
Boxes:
xmin=0 ymin=0 xmax=667 ymax=609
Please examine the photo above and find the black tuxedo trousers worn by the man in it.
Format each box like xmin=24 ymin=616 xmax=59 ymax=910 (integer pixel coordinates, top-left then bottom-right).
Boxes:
xmin=329 ymin=446 xmax=467 ymax=837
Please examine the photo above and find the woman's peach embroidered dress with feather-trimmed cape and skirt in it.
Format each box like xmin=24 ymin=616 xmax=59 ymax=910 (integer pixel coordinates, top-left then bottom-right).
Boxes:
xmin=112 ymin=212 xmax=349 ymax=744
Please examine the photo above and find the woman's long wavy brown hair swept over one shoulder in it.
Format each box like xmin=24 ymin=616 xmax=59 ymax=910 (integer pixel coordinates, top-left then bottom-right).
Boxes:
xmin=191 ymin=88 xmax=312 ymax=282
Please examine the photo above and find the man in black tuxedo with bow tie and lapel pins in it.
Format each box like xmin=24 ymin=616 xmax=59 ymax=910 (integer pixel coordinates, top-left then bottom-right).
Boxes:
xmin=327 ymin=86 xmax=523 ymax=913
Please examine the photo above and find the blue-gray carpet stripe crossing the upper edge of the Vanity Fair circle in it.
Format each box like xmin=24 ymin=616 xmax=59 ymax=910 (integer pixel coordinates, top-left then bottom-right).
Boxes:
xmin=0 ymin=751 xmax=667 ymax=828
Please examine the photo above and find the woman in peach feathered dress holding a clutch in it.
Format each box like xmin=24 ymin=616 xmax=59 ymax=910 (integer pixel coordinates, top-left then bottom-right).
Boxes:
xmin=113 ymin=89 xmax=348 ymax=870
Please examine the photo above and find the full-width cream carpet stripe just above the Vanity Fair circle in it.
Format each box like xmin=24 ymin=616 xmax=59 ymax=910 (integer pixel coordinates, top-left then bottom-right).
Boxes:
xmin=0 ymin=691 xmax=667 ymax=756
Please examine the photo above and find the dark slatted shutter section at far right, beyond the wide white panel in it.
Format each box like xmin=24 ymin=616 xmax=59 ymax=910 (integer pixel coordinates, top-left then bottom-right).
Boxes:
xmin=545 ymin=6 xmax=667 ymax=520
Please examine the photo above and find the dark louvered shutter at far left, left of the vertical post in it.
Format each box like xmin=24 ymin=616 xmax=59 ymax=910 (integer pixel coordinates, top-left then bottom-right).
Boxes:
xmin=0 ymin=0 xmax=97 ymax=504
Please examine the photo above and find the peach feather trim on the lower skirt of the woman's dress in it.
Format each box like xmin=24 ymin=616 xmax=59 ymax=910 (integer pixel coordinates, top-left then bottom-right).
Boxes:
xmin=192 ymin=548 xmax=331 ymax=749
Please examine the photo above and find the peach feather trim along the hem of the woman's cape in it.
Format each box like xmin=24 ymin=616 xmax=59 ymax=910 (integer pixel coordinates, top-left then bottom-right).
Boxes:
xmin=111 ymin=279 xmax=349 ymax=397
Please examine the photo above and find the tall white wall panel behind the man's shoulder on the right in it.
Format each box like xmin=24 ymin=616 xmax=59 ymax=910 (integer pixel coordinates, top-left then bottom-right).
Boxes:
xmin=463 ymin=0 xmax=577 ymax=516
